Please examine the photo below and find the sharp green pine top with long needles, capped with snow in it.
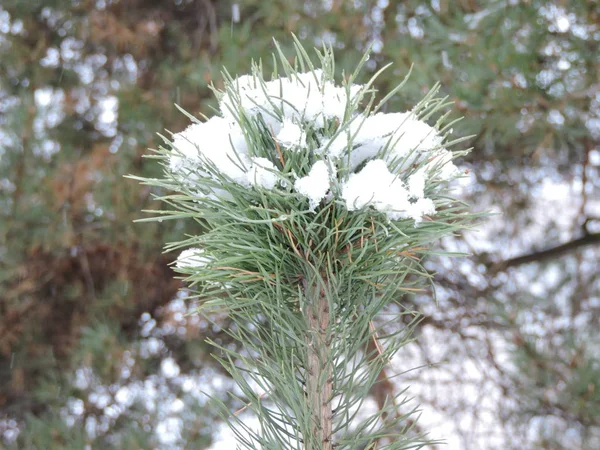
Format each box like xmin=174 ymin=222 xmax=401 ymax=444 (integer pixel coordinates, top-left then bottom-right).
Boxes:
xmin=135 ymin=41 xmax=475 ymax=450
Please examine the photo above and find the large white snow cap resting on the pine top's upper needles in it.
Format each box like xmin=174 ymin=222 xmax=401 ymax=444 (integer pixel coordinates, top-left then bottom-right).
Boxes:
xmin=169 ymin=70 xmax=458 ymax=224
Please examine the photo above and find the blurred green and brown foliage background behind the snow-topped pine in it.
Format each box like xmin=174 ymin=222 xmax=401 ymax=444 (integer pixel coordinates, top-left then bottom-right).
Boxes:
xmin=0 ymin=0 xmax=600 ymax=450
